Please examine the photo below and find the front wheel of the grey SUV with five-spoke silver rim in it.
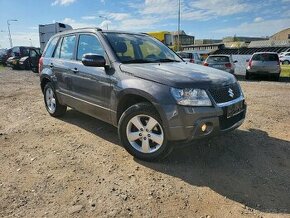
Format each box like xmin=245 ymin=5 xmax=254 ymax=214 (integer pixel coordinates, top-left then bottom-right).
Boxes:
xmin=118 ymin=102 xmax=172 ymax=161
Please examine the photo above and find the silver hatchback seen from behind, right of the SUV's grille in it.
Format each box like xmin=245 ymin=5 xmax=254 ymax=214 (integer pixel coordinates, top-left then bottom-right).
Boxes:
xmin=246 ymin=52 xmax=281 ymax=80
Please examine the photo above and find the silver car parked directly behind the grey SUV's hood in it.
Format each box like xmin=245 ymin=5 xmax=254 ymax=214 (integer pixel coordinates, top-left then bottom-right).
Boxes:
xmin=203 ymin=55 xmax=237 ymax=74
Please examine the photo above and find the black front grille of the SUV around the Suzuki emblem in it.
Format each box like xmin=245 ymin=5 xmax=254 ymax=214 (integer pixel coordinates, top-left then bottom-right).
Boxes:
xmin=209 ymin=83 xmax=241 ymax=103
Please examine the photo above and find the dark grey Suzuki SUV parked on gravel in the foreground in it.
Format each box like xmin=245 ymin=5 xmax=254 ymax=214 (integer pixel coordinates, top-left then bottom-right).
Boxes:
xmin=39 ymin=28 xmax=246 ymax=161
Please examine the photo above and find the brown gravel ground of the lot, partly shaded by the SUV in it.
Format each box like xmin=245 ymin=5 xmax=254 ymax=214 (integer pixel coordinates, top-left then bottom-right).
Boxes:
xmin=0 ymin=68 xmax=290 ymax=217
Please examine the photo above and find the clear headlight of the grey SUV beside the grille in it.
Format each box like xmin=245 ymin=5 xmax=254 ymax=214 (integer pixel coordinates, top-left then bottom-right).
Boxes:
xmin=170 ymin=88 xmax=212 ymax=106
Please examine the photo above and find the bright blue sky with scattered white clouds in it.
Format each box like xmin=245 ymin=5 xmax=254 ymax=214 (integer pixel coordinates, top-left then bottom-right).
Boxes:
xmin=0 ymin=0 xmax=290 ymax=48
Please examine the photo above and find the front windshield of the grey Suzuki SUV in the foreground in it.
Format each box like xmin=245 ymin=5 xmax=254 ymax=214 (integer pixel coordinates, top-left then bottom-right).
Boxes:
xmin=104 ymin=33 xmax=182 ymax=63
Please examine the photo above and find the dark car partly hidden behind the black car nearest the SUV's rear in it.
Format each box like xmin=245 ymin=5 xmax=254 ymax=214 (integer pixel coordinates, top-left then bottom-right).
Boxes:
xmin=6 ymin=46 xmax=37 ymax=69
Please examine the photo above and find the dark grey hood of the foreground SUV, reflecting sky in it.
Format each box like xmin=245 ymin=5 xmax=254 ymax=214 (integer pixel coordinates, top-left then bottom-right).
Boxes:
xmin=120 ymin=62 xmax=236 ymax=88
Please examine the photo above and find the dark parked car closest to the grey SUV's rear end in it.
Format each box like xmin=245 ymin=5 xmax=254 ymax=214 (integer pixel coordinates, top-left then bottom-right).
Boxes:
xmin=19 ymin=48 xmax=41 ymax=73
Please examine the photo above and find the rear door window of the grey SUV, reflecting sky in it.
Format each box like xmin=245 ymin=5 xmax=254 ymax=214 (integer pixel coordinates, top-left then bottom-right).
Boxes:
xmin=60 ymin=35 xmax=76 ymax=60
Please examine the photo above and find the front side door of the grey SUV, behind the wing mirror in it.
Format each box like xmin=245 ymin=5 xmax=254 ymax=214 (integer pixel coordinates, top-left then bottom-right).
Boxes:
xmin=68 ymin=34 xmax=112 ymax=121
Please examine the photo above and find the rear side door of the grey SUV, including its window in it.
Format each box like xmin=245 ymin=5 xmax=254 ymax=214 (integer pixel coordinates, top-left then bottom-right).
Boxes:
xmin=50 ymin=34 xmax=76 ymax=96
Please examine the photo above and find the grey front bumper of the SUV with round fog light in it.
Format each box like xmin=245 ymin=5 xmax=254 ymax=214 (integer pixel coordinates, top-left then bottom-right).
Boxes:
xmin=166 ymin=98 xmax=247 ymax=141
